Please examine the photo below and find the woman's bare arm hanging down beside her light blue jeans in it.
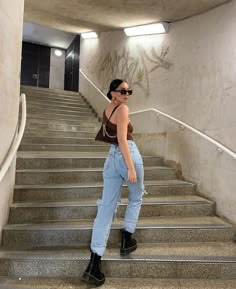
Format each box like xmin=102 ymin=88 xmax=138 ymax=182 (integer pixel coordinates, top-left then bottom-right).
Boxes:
xmin=116 ymin=105 xmax=137 ymax=183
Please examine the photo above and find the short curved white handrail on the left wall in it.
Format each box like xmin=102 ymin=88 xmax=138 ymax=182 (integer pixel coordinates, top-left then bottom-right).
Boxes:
xmin=0 ymin=93 xmax=26 ymax=183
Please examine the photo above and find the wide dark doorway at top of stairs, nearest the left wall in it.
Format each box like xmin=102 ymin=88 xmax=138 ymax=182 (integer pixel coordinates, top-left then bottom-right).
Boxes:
xmin=21 ymin=42 xmax=51 ymax=88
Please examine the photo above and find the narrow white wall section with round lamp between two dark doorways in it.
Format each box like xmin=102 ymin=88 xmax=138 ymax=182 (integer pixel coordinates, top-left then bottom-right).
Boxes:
xmin=49 ymin=48 xmax=65 ymax=89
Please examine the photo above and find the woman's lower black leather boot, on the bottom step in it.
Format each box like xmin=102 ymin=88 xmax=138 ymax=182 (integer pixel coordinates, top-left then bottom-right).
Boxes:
xmin=82 ymin=252 xmax=105 ymax=287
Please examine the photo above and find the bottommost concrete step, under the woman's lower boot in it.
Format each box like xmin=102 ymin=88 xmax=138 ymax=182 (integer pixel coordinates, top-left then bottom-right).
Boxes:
xmin=0 ymin=276 xmax=236 ymax=289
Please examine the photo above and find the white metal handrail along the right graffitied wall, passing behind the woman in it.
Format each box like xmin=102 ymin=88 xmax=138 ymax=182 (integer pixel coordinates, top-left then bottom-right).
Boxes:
xmin=80 ymin=69 xmax=236 ymax=159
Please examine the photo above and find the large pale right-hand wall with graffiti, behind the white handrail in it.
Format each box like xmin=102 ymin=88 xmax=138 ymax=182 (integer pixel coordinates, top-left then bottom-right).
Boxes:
xmin=80 ymin=1 xmax=236 ymax=222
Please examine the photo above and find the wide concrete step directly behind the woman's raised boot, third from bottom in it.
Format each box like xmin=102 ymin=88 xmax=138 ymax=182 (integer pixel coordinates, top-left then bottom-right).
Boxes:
xmin=2 ymin=216 xmax=235 ymax=245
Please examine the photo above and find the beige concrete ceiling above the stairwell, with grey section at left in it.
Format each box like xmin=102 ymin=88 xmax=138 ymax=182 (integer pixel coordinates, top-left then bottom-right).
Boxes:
xmin=23 ymin=0 xmax=231 ymax=49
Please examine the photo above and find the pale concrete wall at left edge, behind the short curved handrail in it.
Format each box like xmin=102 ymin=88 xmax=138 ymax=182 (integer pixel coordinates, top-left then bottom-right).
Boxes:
xmin=0 ymin=0 xmax=24 ymax=241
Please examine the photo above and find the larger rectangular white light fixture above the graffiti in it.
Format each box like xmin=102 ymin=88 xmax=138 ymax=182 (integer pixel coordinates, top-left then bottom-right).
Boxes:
xmin=124 ymin=22 xmax=168 ymax=36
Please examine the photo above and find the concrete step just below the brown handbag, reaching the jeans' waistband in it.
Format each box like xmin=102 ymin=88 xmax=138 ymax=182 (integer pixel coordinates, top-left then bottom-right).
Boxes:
xmin=19 ymin=144 xmax=109 ymax=152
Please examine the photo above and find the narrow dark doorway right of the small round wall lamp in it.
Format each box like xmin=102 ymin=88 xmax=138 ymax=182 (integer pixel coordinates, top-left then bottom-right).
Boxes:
xmin=65 ymin=35 xmax=80 ymax=91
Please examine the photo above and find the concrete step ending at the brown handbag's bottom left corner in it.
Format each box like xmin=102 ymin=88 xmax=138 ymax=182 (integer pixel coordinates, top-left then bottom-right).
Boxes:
xmin=21 ymin=135 xmax=97 ymax=145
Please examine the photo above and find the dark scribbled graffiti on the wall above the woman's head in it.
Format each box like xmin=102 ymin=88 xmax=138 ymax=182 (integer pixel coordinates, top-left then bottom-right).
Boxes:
xmin=95 ymin=46 xmax=172 ymax=96
